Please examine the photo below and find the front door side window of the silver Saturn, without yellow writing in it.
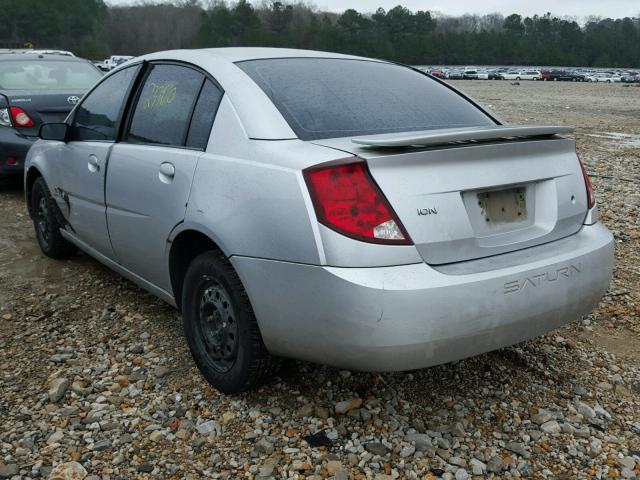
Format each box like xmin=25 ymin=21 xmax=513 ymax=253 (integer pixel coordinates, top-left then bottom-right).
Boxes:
xmin=71 ymin=66 xmax=140 ymax=142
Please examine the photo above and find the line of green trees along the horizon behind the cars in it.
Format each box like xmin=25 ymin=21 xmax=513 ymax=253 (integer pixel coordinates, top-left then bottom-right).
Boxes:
xmin=0 ymin=0 xmax=640 ymax=67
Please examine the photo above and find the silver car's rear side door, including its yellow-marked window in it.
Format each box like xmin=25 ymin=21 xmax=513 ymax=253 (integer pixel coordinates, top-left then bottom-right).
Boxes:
xmin=106 ymin=63 xmax=222 ymax=291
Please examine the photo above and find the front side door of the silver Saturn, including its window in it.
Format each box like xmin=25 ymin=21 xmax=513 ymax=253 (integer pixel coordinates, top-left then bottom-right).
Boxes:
xmin=57 ymin=65 xmax=140 ymax=258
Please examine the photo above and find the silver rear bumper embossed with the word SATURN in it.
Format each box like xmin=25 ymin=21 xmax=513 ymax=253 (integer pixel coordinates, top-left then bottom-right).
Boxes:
xmin=231 ymin=223 xmax=613 ymax=371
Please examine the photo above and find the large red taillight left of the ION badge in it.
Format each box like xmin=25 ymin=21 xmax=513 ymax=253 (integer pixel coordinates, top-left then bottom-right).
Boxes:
xmin=303 ymin=158 xmax=412 ymax=245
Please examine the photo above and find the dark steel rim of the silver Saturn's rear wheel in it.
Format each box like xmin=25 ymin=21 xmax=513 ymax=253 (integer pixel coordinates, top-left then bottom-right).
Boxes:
xmin=198 ymin=282 xmax=238 ymax=373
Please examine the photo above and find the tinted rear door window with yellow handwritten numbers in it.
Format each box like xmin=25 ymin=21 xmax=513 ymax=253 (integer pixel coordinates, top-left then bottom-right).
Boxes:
xmin=127 ymin=65 xmax=204 ymax=146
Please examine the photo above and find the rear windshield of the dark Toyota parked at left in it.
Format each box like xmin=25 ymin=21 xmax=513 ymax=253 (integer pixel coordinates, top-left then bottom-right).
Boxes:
xmin=0 ymin=59 xmax=102 ymax=90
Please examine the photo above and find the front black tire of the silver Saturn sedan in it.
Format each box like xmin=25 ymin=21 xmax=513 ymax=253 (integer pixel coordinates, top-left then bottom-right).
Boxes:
xmin=31 ymin=177 xmax=78 ymax=259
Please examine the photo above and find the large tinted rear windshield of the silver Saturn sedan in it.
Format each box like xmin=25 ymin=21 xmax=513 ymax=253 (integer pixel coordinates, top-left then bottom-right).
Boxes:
xmin=237 ymin=58 xmax=494 ymax=140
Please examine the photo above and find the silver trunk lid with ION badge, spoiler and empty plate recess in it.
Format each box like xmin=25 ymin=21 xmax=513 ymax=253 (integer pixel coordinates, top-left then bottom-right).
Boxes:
xmin=314 ymin=126 xmax=587 ymax=264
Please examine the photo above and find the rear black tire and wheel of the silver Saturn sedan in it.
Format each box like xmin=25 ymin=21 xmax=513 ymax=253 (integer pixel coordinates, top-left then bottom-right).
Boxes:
xmin=182 ymin=251 xmax=280 ymax=394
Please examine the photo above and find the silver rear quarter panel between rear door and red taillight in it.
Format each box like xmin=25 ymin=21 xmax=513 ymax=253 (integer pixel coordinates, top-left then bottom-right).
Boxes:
xmin=180 ymin=96 xmax=345 ymax=264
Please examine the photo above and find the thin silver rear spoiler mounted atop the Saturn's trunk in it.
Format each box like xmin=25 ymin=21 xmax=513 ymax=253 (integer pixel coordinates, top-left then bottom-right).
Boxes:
xmin=351 ymin=125 xmax=575 ymax=148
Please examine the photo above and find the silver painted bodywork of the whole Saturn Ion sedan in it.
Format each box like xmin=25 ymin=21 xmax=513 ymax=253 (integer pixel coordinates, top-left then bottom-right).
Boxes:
xmin=25 ymin=48 xmax=613 ymax=370
